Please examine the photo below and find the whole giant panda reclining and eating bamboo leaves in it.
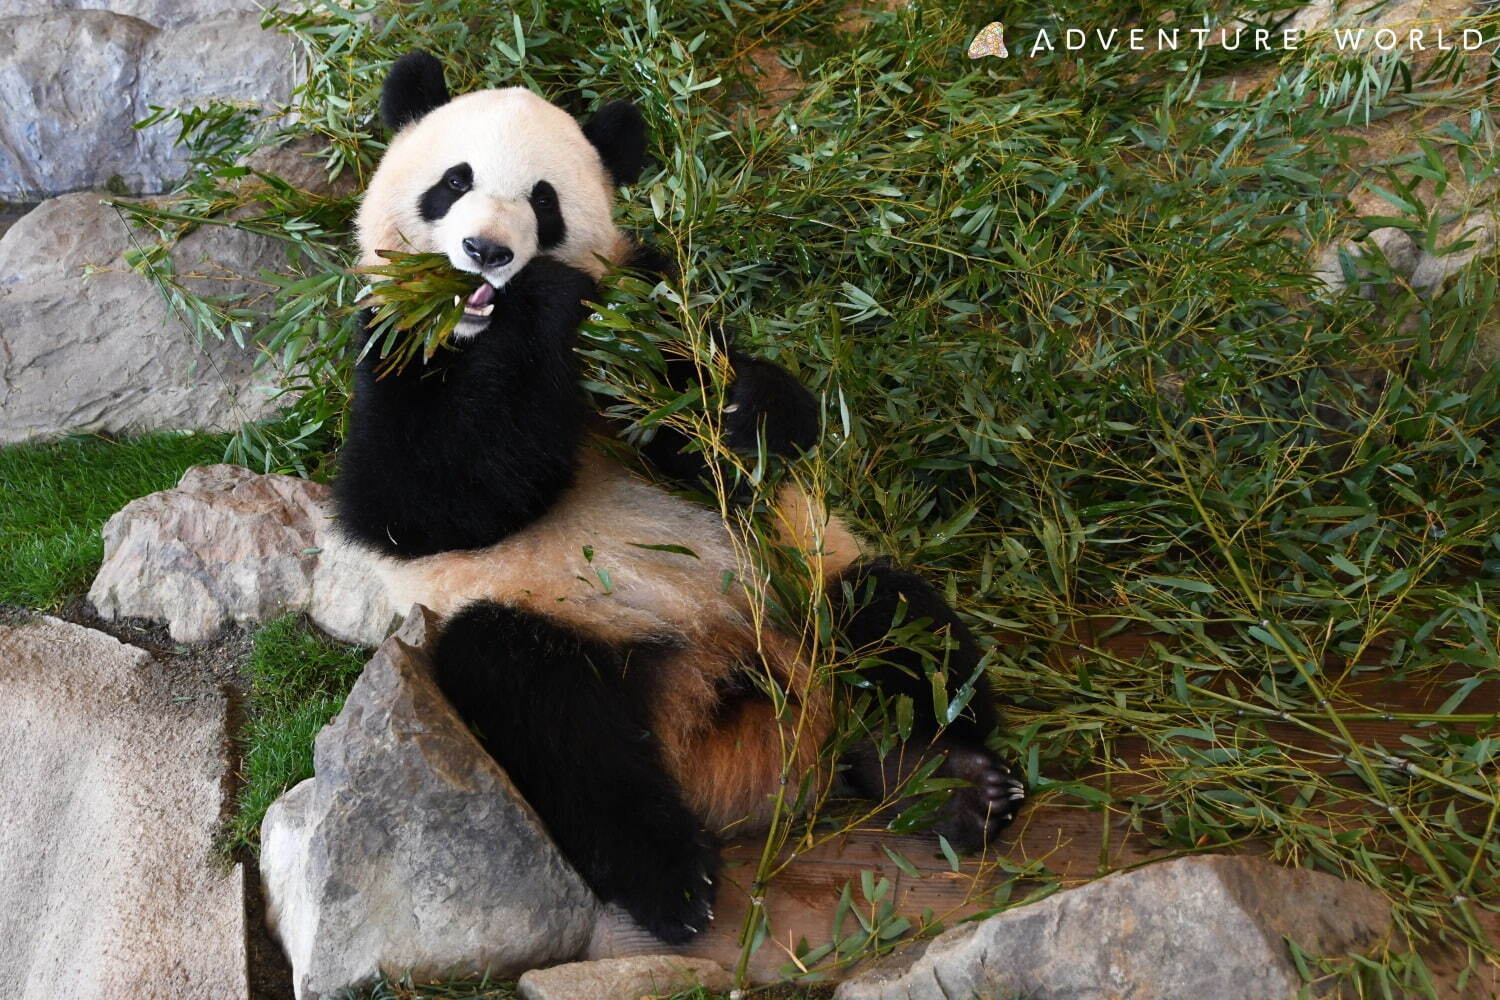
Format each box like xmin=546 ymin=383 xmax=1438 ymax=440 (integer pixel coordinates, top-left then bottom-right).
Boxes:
xmin=335 ymin=51 xmax=1025 ymax=943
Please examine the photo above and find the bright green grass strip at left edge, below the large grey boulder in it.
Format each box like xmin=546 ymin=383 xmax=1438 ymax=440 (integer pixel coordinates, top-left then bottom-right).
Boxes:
xmin=0 ymin=433 xmax=227 ymax=610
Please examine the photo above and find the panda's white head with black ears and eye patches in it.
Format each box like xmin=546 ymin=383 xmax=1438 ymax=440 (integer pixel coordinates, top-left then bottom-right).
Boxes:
xmin=357 ymin=51 xmax=645 ymax=336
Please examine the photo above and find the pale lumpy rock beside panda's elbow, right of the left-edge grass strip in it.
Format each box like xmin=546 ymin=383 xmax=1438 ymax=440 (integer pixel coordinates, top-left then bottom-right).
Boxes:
xmin=89 ymin=465 xmax=396 ymax=646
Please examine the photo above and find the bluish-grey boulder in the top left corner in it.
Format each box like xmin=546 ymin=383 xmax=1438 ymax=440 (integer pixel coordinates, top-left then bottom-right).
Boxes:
xmin=0 ymin=10 xmax=296 ymax=201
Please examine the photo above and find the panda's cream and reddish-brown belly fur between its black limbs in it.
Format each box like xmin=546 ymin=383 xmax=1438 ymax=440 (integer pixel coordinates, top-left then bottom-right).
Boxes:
xmin=383 ymin=451 xmax=860 ymax=834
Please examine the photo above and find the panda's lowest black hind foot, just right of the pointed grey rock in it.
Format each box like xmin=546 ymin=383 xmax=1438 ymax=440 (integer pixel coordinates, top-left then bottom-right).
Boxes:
xmin=614 ymin=831 xmax=719 ymax=945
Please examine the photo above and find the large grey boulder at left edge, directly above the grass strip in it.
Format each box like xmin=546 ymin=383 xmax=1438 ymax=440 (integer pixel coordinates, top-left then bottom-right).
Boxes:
xmin=0 ymin=193 xmax=286 ymax=445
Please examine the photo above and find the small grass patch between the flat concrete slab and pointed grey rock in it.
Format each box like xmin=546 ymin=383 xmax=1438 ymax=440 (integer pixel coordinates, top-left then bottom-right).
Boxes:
xmin=222 ymin=615 xmax=369 ymax=853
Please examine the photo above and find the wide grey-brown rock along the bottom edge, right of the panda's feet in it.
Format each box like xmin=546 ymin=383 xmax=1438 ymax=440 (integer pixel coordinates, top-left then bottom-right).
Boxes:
xmin=834 ymin=856 xmax=1394 ymax=1000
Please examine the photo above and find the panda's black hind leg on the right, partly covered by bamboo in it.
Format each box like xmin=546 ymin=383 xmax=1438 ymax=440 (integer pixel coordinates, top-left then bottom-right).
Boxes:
xmin=830 ymin=559 xmax=1026 ymax=852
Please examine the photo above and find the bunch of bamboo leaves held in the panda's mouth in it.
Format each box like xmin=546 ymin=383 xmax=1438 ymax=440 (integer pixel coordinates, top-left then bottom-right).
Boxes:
xmin=357 ymin=250 xmax=479 ymax=378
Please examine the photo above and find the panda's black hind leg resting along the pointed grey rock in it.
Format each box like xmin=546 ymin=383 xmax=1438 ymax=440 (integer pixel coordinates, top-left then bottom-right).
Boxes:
xmin=434 ymin=603 xmax=719 ymax=943
